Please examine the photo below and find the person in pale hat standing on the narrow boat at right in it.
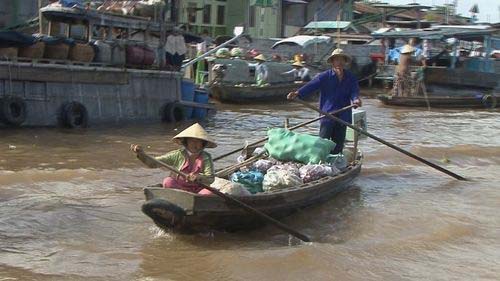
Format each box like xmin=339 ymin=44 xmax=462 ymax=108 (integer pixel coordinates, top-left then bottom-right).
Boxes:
xmin=392 ymin=45 xmax=415 ymax=97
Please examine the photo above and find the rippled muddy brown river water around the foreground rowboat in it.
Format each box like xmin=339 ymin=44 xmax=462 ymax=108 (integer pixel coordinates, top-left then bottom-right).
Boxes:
xmin=0 ymin=99 xmax=500 ymax=281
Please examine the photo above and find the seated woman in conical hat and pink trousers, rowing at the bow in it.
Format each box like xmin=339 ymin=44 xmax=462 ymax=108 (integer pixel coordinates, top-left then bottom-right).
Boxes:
xmin=130 ymin=123 xmax=217 ymax=194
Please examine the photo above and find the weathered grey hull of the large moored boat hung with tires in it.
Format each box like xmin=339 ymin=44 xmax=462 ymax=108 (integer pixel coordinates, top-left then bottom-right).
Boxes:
xmin=0 ymin=61 xmax=182 ymax=127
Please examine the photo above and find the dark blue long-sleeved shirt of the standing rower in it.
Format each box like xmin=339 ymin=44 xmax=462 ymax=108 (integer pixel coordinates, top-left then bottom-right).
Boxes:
xmin=298 ymin=69 xmax=359 ymax=123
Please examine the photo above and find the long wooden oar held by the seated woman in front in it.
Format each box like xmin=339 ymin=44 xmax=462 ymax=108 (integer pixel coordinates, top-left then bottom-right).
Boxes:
xmin=135 ymin=153 xmax=311 ymax=242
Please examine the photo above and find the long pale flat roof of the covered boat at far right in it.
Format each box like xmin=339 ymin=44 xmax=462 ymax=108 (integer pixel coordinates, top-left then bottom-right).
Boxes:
xmin=372 ymin=26 xmax=499 ymax=41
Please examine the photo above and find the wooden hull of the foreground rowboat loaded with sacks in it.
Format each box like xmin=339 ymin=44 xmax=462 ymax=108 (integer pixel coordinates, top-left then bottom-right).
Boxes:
xmin=142 ymin=145 xmax=363 ymax=233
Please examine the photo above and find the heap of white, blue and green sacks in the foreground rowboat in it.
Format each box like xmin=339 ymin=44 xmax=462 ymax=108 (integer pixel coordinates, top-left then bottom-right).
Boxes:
xmin=212 ymin=129 xmax=349 ymax=195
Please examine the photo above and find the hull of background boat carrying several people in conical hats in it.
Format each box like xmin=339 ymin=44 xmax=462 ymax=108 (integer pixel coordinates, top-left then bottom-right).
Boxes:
xmin=210 ymin=82 xmax=304 ymax=104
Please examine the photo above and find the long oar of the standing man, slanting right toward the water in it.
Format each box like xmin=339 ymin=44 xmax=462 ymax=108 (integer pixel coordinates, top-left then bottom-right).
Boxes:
xmin=293 ymin=99 xmax=467 ymax=180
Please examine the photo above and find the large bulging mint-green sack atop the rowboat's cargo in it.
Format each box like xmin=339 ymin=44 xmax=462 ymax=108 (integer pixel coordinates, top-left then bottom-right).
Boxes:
xmin=264 ymin=128 xmax=335 ymax=164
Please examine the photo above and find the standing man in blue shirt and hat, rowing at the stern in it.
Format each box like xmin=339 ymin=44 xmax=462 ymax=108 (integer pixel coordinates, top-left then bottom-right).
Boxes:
xmin=287 ymin=49 xmax=361 ymax=154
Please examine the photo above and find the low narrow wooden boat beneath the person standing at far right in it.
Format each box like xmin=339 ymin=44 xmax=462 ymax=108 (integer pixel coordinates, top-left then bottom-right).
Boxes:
xmin=377 ymin=94 xmax=500 ymax=108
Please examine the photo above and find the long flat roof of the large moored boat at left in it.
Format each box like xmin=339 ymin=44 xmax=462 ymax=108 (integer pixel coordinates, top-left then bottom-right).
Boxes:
xmin=40 ymin=6 xmax=173 ymax=32
